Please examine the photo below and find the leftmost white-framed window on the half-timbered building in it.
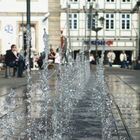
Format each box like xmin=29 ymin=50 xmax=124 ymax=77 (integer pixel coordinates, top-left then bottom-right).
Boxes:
xmin=69 ymin=13 xmax=78 ymax=29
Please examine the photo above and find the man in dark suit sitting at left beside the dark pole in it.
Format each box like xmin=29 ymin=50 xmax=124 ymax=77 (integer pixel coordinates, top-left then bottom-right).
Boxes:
xmin=5 ymin=44 xmax=25 ymax=77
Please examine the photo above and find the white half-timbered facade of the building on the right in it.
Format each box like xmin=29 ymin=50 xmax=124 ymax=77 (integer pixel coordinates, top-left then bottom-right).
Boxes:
xmin=61 ymin=0 xmax=138 ymax=60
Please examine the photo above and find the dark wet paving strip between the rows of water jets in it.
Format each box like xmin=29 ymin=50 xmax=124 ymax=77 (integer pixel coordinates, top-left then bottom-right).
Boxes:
xmin=64 ymin=73 xmax=118 ymax=140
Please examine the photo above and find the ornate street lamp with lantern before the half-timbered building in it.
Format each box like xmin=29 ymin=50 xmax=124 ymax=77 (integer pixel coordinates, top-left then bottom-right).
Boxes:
xmin=92 ymin=11 xmax=105 ymax=59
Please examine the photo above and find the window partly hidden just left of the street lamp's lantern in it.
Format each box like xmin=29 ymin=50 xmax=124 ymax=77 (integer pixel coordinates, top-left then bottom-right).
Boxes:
xmin=87 ymin=14 xmax=96 ymax=29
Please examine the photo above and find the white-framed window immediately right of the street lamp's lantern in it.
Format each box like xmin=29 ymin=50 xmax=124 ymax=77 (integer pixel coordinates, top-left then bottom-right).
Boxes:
xmin=106 ymin=14 xmax=114 ymax=29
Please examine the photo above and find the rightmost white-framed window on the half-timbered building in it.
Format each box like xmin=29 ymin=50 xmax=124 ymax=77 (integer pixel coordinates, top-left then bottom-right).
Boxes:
xmin=121 ymin=14 xmax=130 ymax=29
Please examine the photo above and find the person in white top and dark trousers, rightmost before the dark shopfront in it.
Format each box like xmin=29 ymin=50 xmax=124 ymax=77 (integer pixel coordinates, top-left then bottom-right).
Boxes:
xmin=120 ymin=51 xmax=128 ymax=68
